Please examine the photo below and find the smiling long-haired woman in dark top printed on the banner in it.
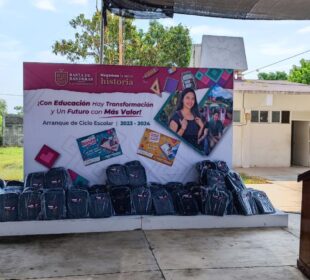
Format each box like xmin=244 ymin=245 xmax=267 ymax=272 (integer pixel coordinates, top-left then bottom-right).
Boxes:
xmin=169 ymin=88 xmax=204 ymax=149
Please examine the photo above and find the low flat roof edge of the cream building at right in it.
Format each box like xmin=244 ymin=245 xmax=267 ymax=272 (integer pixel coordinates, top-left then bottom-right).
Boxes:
xmin=234 ymin=80 xmax=310 ymax=94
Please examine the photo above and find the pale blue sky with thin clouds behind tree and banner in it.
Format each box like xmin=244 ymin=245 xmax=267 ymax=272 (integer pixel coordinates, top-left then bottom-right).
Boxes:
xmin=0 ymin=0 xmax=310 ymax=113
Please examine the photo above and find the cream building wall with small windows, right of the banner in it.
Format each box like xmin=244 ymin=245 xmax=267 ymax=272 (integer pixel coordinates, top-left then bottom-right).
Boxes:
xmin=233 ymin=91 xmax=310 ymax=167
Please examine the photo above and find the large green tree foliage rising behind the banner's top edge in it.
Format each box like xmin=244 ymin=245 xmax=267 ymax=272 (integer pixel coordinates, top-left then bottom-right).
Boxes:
xmin=52 ymin=11 xmax=192 ymax=67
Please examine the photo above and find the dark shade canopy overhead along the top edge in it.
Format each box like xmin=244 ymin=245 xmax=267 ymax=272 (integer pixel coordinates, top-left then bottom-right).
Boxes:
xmin=104 ymin=0 xmax=310 ymax=20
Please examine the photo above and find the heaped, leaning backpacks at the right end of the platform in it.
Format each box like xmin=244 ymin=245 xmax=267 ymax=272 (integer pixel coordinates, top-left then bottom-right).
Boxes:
xmin=196 ymin=160 xmax=275 ymax=216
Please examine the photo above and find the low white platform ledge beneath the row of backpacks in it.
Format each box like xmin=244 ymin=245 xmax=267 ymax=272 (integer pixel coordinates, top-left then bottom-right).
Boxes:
xmin=0 ymin=211 xmax=288 ymax=236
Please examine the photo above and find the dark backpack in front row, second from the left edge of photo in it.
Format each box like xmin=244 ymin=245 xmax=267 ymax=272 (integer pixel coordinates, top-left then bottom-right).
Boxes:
xmin=18 ymin=188 xmax=42 ymax=221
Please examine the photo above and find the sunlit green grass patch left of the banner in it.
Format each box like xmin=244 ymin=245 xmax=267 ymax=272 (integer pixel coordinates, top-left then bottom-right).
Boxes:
xmin=0 ymin=147 xmax=24 ymax=181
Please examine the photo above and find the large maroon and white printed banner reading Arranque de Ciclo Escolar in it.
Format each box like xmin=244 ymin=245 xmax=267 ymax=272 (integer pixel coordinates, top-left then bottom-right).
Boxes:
xmin=24 ymin=63 xmax=233 ymax=184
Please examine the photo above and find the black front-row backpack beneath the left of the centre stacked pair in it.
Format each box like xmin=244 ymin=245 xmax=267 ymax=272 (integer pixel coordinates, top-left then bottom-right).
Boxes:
xmin=110 ymin=186 xmax=132 ymax=215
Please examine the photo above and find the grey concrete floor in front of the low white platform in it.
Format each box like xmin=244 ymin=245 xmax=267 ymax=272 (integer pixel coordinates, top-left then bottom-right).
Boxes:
xmin=0 ymin=215 xmax=306 ymax=280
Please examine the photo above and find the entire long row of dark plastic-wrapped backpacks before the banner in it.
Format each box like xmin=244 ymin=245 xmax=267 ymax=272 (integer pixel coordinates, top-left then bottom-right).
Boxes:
xmin=0 ymin=160 xmax=275 ymax=222
